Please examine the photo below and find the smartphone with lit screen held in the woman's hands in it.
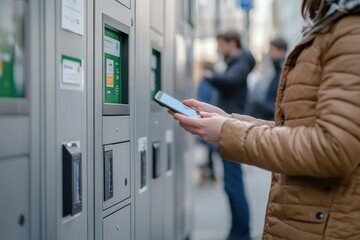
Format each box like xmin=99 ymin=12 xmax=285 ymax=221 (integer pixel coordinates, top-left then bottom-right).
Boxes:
xmin=154 ymin=91 xmax=201 ymax=118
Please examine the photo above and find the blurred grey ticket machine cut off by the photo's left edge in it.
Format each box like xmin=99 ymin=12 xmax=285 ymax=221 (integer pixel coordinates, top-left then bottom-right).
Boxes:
xmin=0 ymin=0 xmax=38 ymax=240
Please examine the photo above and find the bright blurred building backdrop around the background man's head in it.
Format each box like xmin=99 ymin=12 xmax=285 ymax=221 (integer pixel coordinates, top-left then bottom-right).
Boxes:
xmin=194 ymin=0 xmax=274 ymax=82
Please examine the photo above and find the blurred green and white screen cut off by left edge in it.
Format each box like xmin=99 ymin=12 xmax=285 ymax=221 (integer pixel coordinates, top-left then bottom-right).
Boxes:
xmin=0 ymin=1 xmax=25 ymax=98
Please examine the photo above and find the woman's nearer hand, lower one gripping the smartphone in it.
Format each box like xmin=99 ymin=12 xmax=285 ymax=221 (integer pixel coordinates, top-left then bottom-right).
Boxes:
xmin=168 ymin=111 xmax=228 ymax=143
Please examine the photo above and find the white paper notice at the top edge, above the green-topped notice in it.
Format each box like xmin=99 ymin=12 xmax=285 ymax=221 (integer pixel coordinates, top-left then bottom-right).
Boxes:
xmin=61 ymin=0 xmax=84 ymax=35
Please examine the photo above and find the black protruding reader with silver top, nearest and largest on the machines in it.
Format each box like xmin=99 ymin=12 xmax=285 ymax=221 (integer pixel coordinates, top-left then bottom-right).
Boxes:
xmin=62 ymin=143 xmax=82 ymax=217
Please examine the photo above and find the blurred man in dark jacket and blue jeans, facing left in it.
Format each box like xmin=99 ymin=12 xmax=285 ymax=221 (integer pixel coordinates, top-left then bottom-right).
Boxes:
xmin=204 ymin=31 xmax=255 ymax=240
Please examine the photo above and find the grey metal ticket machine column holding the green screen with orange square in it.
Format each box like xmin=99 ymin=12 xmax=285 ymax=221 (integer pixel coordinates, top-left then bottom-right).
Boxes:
xmin=94 ymin=0 xmax=134 ymax=240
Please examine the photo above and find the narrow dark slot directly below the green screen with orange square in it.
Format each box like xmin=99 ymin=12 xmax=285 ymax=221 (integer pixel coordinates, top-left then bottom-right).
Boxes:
xmin=104 ymin=150 xmax=114 ymax=201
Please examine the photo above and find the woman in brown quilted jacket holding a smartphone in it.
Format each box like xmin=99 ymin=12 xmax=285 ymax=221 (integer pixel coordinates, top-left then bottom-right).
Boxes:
xmin=170 ymin=0 xmax=360 ymax=240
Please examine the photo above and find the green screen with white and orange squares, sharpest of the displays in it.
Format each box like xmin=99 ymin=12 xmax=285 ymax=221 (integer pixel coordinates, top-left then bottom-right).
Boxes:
xmin=104 ymin=28 xmax=122 ymax=104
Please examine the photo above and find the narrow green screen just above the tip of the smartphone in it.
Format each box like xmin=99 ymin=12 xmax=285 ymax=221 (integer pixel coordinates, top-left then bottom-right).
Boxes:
xmin=150 ymin=49 xmax=161 ymax=101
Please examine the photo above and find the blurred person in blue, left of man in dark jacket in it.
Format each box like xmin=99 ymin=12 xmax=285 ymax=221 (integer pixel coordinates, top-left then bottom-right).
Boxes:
xmin=197 ymin=62 xmax=217 ymax=183
